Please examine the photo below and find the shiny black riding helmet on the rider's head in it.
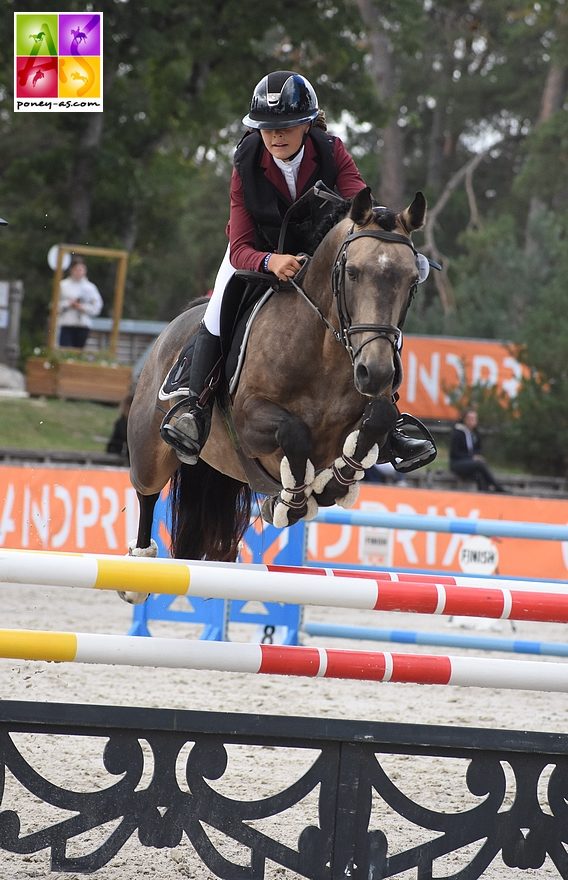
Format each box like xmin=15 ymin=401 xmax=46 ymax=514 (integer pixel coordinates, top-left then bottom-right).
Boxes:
xmin=243 ymin=70 xmax=318 ymax=129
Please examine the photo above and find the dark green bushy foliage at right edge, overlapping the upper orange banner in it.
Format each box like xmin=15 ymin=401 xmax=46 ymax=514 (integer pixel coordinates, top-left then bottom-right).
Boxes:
xmin=440 ymin=211 xmax=568 ymax=476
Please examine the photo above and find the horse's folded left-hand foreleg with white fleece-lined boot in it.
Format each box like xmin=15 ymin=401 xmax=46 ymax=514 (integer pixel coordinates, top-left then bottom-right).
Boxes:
xmin=239 ymin=401 xmax=317 ymax=528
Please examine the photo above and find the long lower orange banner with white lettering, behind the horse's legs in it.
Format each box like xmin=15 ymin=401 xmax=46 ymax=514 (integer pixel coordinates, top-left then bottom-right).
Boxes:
xmin=0 ymin=466 xmax=568 ymax=580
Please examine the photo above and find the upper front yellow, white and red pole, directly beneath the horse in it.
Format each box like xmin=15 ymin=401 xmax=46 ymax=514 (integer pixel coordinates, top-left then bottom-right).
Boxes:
xmin=0 ymin=551 xmax=568 ymax=623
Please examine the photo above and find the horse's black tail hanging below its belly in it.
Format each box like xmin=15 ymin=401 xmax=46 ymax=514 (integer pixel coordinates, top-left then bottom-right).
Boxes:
xmin=170 ymin=459 xmax=252 ymax=562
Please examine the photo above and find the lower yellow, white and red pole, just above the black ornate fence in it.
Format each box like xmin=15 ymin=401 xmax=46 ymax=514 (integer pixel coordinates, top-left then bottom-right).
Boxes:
xmin=0 ymin=630 xmax=568 ymax=693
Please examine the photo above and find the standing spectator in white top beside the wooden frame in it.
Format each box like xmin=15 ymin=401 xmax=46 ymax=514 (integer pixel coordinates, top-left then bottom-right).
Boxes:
xmin=59 ymin=257 xmax=103 ymax=348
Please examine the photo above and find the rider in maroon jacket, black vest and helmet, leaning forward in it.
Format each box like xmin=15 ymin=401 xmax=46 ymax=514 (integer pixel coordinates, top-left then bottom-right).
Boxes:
xmin=160 ymin=70 xmax=435 ymax=469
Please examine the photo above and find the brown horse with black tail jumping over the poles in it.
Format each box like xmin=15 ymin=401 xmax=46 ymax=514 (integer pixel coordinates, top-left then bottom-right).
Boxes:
xmin=127 ymin=188 xmax=426 ymax=561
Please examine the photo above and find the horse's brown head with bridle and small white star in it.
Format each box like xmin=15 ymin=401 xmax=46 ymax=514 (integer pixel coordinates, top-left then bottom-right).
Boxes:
xmin=333 ymin=188 xmax=426 ymax=397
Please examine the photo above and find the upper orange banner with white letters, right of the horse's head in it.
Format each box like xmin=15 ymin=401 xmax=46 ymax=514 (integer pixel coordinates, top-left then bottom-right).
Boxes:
xmin=399 ymin=335 xmax=526 ymax=421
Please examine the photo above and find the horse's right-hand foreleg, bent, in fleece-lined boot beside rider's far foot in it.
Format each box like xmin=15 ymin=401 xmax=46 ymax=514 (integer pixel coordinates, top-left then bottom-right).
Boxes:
xmin=312 ymin=397 xmax=398 ymax=507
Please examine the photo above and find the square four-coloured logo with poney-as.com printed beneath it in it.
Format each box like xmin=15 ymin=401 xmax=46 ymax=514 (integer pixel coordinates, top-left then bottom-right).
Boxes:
xmin=14 ymin=12 xmax=103 ymax=112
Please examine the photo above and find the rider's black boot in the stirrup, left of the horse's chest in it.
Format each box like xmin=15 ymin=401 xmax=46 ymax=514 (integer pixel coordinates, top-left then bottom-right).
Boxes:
xmin=160 ymin=324 xmax=221 ymax=464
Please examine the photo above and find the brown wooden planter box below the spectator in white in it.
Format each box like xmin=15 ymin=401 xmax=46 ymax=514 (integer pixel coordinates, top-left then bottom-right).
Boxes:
xmin=26 ymin=357 xmax=132 ymax=403
